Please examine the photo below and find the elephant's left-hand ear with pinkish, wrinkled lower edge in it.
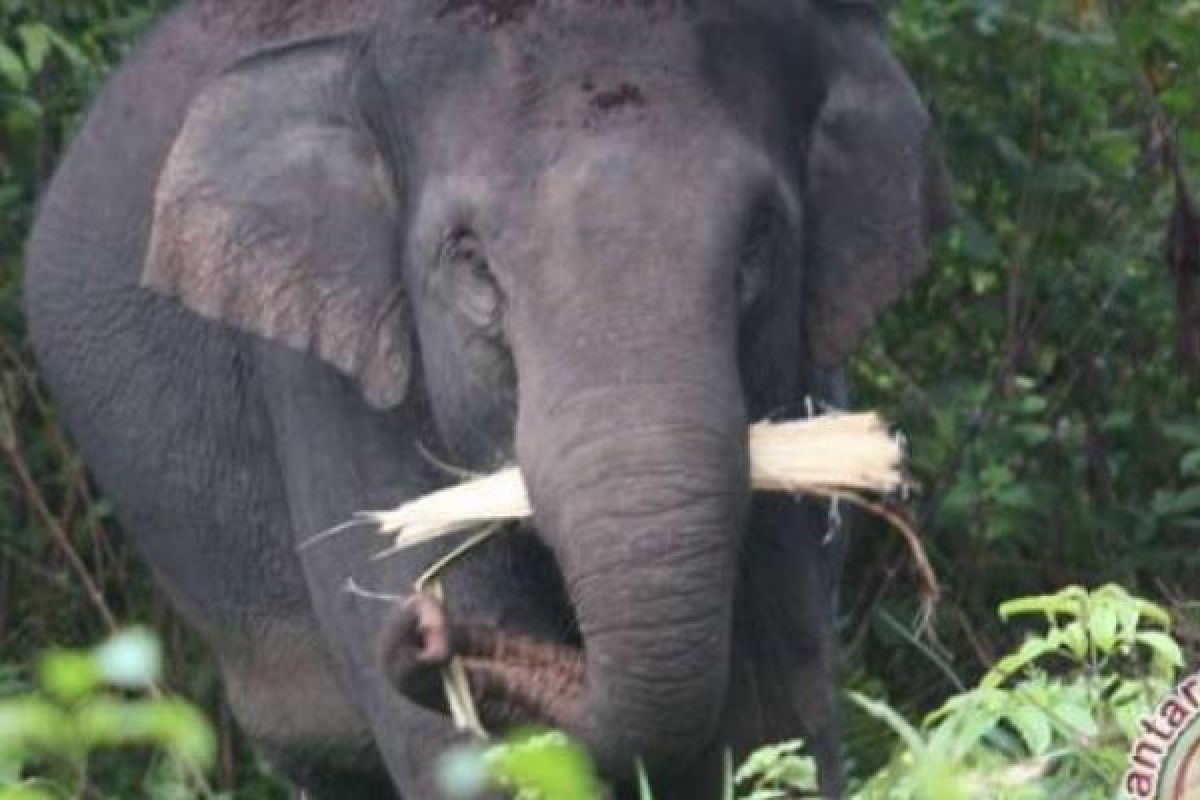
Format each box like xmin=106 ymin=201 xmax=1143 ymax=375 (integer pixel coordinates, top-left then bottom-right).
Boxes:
xmin=142 ymin=38 xmax=412 ymax=408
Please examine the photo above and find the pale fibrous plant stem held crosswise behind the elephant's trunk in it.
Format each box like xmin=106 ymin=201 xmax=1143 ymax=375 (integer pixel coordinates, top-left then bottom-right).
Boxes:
xmin=356 ymin=413 xmax=906 ymax=548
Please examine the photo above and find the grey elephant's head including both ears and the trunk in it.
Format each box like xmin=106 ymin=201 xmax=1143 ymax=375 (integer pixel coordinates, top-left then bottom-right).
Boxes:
xmin=144 ymin=0 xmax=947 ymax=786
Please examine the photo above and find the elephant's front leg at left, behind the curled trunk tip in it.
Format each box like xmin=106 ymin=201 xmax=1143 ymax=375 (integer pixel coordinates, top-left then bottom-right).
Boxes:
xmin=263 ymin=345 xmax=570 ymax=800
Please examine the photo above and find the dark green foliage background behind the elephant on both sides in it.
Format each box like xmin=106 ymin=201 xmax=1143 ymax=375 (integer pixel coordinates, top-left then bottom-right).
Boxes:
xmin=0 ymin=0 xmax=1200 ymax=798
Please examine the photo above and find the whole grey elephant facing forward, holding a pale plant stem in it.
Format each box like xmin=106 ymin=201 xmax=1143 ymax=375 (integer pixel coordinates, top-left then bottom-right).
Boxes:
xmin=24 ymin=0 xmax=950 ymax=800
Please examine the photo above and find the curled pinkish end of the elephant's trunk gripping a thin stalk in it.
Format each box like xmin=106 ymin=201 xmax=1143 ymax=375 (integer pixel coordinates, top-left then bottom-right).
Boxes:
xmin=379 ymin=593 xmax=586 ymax=730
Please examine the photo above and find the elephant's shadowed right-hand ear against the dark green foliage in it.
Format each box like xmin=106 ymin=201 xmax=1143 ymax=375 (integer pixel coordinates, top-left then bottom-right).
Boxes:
xmin=804 ymin=8 xmax=950 ymax=366
